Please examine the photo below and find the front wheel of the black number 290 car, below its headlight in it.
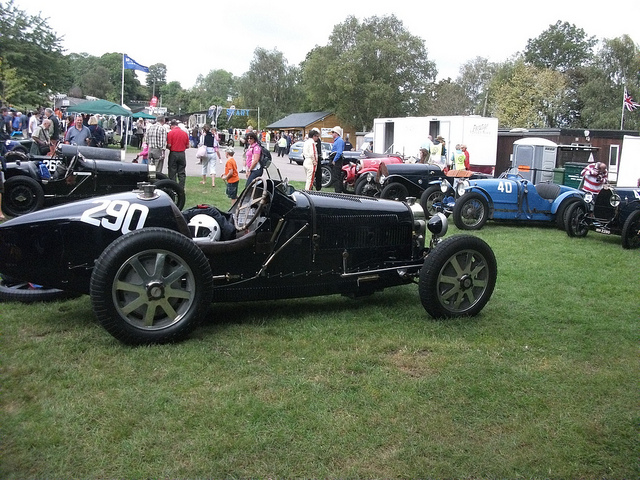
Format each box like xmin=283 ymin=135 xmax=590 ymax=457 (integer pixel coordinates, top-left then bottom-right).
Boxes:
xmin=418 ymin=235 xmax=498 ymax=318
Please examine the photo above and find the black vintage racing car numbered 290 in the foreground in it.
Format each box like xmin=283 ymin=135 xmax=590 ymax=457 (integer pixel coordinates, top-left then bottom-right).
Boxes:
xmin=0 ymin=173 xmax=497 ymax=344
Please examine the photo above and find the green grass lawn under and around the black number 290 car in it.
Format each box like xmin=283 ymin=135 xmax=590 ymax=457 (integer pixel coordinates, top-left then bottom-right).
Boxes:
xmin=0 ymin=177 xmax=640 ymax=479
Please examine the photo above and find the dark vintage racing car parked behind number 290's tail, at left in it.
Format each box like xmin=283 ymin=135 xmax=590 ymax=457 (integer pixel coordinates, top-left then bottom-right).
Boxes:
xmin=2 ymin=144 xmax=185 ymax=217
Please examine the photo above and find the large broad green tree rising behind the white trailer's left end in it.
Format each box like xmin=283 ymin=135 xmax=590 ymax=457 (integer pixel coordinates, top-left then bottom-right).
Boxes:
xmin=302 ymin=15 xmax=436 ymax=130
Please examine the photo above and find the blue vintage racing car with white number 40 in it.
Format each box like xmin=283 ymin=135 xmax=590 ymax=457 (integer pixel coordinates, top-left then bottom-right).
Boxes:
xmin=449 ymin=173 xmax=584 ymax=230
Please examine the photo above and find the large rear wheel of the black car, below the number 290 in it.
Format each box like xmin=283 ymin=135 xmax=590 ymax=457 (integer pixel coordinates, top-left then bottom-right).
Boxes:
xmin=90 ymin=228 xmax=213 ymax=345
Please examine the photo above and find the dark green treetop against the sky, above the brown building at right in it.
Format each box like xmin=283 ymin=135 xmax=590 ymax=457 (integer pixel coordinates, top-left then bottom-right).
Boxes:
xmin=524 ymin=20 xmax=597 ymax=72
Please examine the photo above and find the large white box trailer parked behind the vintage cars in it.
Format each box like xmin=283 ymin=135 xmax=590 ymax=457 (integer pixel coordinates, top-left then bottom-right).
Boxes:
xmin=373 ymin=115 xmax=498 ymax=171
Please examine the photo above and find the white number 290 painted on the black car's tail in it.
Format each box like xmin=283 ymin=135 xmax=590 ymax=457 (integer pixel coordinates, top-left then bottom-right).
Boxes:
xmin=80 ymin=200 xmax=149 ymax=234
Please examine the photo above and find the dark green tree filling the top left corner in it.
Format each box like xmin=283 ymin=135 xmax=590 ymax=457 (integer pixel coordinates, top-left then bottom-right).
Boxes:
xmin=0 ymin=0 xmax=69 ymax=106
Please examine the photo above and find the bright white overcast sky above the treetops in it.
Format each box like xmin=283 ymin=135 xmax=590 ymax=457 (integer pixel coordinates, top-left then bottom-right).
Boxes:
xmin=21 ymin=0 xmax=640 ymax=93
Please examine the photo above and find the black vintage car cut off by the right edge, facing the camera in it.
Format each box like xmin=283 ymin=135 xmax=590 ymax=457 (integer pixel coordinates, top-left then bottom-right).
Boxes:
xmin=564 ymin=185 xmax=640 ymax=248
